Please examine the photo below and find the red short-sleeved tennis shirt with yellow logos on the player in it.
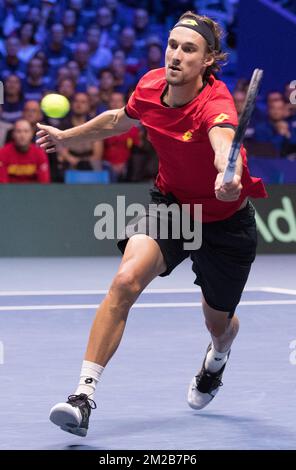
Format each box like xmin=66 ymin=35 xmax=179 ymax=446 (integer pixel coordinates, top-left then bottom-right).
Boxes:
xmin=126 ymin=68 xmax=267 ymax=222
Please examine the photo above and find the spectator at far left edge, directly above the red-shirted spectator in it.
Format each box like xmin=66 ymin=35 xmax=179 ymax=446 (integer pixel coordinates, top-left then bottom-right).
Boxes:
xmin=2 ymin=75 xmax=24 ymax=123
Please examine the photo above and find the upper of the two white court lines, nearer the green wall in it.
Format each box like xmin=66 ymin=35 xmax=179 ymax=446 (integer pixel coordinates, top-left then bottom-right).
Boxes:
xmin=0 ymin=286 xmax=296 ymax=297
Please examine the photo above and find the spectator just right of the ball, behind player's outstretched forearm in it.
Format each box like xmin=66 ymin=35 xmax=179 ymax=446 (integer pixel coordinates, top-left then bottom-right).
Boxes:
xmin=58 ymin=93 xmax=103 ymax=170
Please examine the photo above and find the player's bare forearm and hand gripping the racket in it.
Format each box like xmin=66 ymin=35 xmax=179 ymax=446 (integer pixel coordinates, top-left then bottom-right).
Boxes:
xmin=209 ymin=126 xmax=243 ymax=201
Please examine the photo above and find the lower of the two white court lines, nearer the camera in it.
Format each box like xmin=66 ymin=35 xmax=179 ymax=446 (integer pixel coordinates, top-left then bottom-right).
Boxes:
xmin=0 ymin=300 xmax=296 ymax=311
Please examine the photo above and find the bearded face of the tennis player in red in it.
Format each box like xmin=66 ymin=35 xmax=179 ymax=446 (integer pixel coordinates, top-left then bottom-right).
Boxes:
xmin=165 ymin=27 xmax=213 ymax=86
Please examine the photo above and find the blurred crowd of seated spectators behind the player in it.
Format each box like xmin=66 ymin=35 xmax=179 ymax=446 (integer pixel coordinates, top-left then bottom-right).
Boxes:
xmin=0 ymin=0 xmax=296 ymax=183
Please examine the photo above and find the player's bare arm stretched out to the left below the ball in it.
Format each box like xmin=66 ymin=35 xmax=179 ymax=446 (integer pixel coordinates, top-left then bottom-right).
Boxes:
xmin=36 ymin=108 xmax=137 ymax=153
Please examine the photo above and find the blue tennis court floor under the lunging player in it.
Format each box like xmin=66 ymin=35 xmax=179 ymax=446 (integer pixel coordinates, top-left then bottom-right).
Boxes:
xmin=0 ymin=256 xmax=296 ymax=450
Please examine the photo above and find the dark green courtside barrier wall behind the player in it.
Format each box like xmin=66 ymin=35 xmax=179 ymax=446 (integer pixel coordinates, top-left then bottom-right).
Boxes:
xmin=0 ymin=184 xmax=296 ymax=257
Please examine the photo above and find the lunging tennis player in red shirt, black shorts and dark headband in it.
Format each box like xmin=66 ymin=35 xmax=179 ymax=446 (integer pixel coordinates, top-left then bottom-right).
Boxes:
xmin=39 ymin=12 xmax=266 ymax=435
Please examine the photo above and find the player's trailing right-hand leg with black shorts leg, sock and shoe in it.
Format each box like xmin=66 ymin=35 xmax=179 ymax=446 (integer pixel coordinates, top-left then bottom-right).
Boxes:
xmin=188 ymin=203 xmax=257 ymax=409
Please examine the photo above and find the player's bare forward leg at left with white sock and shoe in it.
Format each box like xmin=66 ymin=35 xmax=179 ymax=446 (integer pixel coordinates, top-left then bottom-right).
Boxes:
xmin=50 ymin=234 xmax=166 ymax=436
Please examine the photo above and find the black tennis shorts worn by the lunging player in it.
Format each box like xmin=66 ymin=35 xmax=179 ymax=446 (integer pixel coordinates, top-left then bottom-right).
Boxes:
xmin=117 ymin=188 xmax=257 ymax=317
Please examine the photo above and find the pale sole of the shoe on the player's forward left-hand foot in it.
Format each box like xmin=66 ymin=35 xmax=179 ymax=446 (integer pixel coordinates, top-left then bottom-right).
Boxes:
xmin=49 ymin=404 xmax=87 ymax=437
